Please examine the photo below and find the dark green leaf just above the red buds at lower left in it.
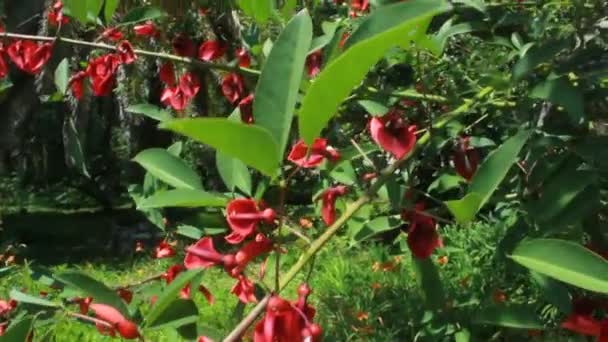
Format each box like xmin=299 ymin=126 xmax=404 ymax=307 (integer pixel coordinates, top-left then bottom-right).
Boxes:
xmin=55 ymin=271 xmax=129 ymax=316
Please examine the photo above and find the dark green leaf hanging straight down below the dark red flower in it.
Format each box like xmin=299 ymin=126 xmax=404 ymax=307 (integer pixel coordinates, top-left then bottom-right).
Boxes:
xmin=412 ymin=255 xmax=446 ymax=310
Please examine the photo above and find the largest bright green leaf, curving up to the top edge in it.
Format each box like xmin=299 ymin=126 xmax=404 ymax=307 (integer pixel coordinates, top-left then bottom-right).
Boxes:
xmin=299 ymin=0 xmax=450 ymax=144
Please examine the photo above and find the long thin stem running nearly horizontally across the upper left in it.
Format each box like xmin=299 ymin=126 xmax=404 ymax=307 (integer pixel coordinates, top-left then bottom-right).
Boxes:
xmin=0 ymin=32 xmax=260 ymax=76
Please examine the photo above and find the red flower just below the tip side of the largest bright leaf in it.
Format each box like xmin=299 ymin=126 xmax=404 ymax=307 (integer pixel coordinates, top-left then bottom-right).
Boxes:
xmin=369 ymin=111 xmax=416 ymax=159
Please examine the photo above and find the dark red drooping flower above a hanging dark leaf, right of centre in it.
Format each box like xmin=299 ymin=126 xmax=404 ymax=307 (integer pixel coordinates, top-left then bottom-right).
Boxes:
xmin=401 ymin=203 xmax=443 ymax=259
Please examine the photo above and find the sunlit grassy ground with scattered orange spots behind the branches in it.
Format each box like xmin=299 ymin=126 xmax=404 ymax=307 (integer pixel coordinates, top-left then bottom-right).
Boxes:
xmin=0 ymin=220 xmax=572 ymax=341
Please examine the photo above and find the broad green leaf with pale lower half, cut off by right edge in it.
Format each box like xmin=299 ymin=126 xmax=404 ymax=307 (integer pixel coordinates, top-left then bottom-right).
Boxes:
xmin=510 ymin=239 xmax=608 ymax=293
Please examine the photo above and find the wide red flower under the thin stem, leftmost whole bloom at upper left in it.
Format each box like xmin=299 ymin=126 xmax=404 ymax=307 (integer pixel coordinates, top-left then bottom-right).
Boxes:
xmin=6 ymin=40 xmax=53 ymax=75
